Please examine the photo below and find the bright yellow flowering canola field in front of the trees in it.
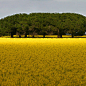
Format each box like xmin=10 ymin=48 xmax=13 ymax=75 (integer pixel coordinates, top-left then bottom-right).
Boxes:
xmin=0 ymin=38 xmax=86 ymax=86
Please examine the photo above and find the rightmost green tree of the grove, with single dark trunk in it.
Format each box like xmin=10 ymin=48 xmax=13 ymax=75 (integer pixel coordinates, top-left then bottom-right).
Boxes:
xmin=61 ymin=13 xmax=85 ymax=38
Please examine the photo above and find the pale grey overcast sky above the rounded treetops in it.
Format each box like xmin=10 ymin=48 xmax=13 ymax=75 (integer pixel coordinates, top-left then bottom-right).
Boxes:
xmin=0 ymin=0 xmax=86 ymax=19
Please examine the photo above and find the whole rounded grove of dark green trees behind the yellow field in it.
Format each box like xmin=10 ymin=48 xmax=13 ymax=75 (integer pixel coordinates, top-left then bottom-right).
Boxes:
xmin=0 ymin=13 xmax=86 ymax=38
